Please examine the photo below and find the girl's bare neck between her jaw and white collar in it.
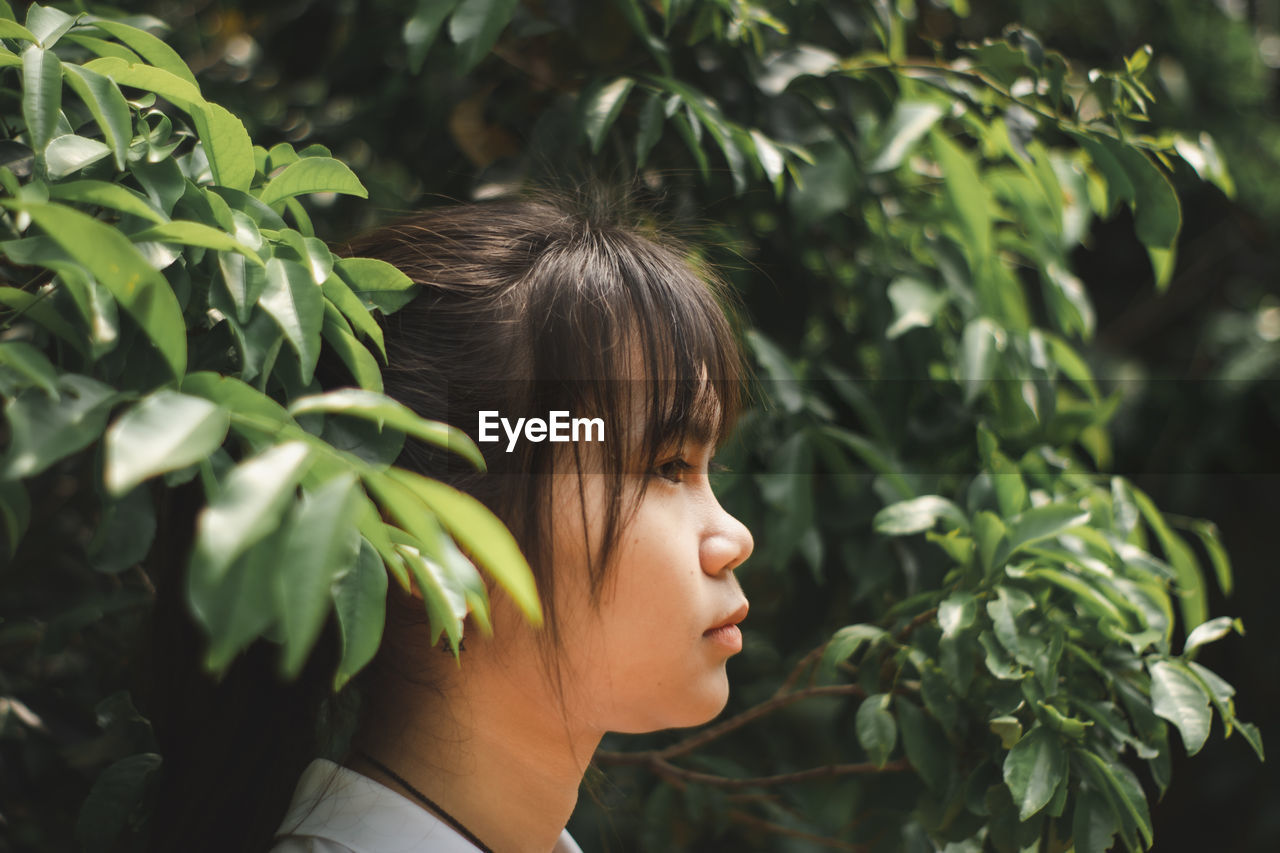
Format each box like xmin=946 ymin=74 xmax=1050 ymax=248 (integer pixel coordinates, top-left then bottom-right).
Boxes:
xmin=357 ymin=646 xmax=602 ymax=853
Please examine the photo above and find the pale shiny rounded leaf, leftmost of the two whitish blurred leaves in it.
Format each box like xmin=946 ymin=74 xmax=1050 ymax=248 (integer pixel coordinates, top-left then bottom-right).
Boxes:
xmin=102 ymin=389 xmax=230 ymax=496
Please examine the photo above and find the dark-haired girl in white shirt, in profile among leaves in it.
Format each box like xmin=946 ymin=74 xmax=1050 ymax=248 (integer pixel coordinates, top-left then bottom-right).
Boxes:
xmin=151 ymin=195 xmax=751 ymax=853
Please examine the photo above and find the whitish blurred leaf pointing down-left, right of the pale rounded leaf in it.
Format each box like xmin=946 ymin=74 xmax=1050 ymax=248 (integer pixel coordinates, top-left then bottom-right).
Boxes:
xmin=191 ymin=442 xmax=311 ymax=585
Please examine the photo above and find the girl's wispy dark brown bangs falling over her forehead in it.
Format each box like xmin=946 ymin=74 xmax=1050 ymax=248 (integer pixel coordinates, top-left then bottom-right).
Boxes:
xmin=524 ymin=225 xmax=745 ymax=473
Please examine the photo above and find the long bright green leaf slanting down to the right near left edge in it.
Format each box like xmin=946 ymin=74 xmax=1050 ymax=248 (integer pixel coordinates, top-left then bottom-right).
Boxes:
xmin=5 ymin=202 xmax=187 ymax=378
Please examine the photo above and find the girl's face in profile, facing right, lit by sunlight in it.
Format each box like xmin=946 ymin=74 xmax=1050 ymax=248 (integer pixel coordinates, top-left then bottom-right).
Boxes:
xmin=553 ymin=425 xmax=753 ymax=733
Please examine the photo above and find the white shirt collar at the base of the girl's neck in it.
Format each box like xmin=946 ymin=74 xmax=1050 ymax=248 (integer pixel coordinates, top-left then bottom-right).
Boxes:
xmin=271 ymin=758 xmax=582 ymax=853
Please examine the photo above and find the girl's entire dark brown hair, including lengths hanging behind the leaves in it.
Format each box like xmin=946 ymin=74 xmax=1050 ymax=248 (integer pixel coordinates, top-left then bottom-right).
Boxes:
xmin=151 ymin=197 xmax=742 ymax=850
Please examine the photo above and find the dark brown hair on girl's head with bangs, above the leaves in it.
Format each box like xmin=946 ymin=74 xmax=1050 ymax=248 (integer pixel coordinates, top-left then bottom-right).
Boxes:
xmin=346 ymin=199 xmax=742 ymax=640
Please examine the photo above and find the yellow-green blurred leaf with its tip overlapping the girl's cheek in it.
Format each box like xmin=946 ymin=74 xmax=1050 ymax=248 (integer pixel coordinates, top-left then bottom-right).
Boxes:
xmin=388 ymin=469 xmax=543 ymax=625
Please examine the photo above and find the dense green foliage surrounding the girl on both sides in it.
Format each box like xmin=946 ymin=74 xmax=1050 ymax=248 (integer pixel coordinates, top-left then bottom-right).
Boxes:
xmin=0 ymin=0 xmax=1262 ymax=853
